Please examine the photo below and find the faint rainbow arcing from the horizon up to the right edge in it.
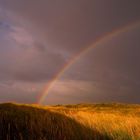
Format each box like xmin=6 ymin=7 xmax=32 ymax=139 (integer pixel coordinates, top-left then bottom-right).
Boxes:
xmin=37 ymin=21 xmax=140 ymax=104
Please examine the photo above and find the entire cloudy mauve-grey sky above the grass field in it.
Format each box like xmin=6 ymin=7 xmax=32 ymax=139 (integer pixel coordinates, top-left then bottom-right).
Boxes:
xmin=0 ymin=0 xmax=140 ymax=104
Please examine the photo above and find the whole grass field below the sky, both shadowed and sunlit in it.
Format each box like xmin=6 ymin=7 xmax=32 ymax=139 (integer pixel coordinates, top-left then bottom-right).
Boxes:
xmin=0 ymin=103 xmax=140 ymax=140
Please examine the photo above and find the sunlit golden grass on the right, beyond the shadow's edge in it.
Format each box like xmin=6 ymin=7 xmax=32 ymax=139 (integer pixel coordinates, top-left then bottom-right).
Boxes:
xmin=43 ymin=104 xmax=140 ymax=140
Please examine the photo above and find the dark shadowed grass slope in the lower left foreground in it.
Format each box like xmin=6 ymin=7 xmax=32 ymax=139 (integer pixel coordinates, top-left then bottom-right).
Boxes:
xmin=0 ymin=103 xmax=111 ymax=140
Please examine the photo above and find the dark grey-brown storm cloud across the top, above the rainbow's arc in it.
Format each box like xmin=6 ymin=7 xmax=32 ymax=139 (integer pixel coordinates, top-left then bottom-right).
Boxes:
xmin=1 ymin=0 xmax=140 ymax=52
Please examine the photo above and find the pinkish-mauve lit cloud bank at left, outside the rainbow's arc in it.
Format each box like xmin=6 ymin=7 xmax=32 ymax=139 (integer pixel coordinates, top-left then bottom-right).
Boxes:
xmin=0 ymin=16 xmax=65 ymax=82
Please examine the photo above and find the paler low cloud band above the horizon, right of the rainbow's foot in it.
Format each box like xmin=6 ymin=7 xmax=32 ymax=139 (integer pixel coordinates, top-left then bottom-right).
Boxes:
xmin=43 ymin=80 xmax=140 ymax=104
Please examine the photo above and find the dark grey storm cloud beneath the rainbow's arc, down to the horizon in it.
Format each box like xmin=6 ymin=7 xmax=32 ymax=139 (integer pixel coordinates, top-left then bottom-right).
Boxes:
xmin=49 ymin=26 xmax=140 ymax=103
